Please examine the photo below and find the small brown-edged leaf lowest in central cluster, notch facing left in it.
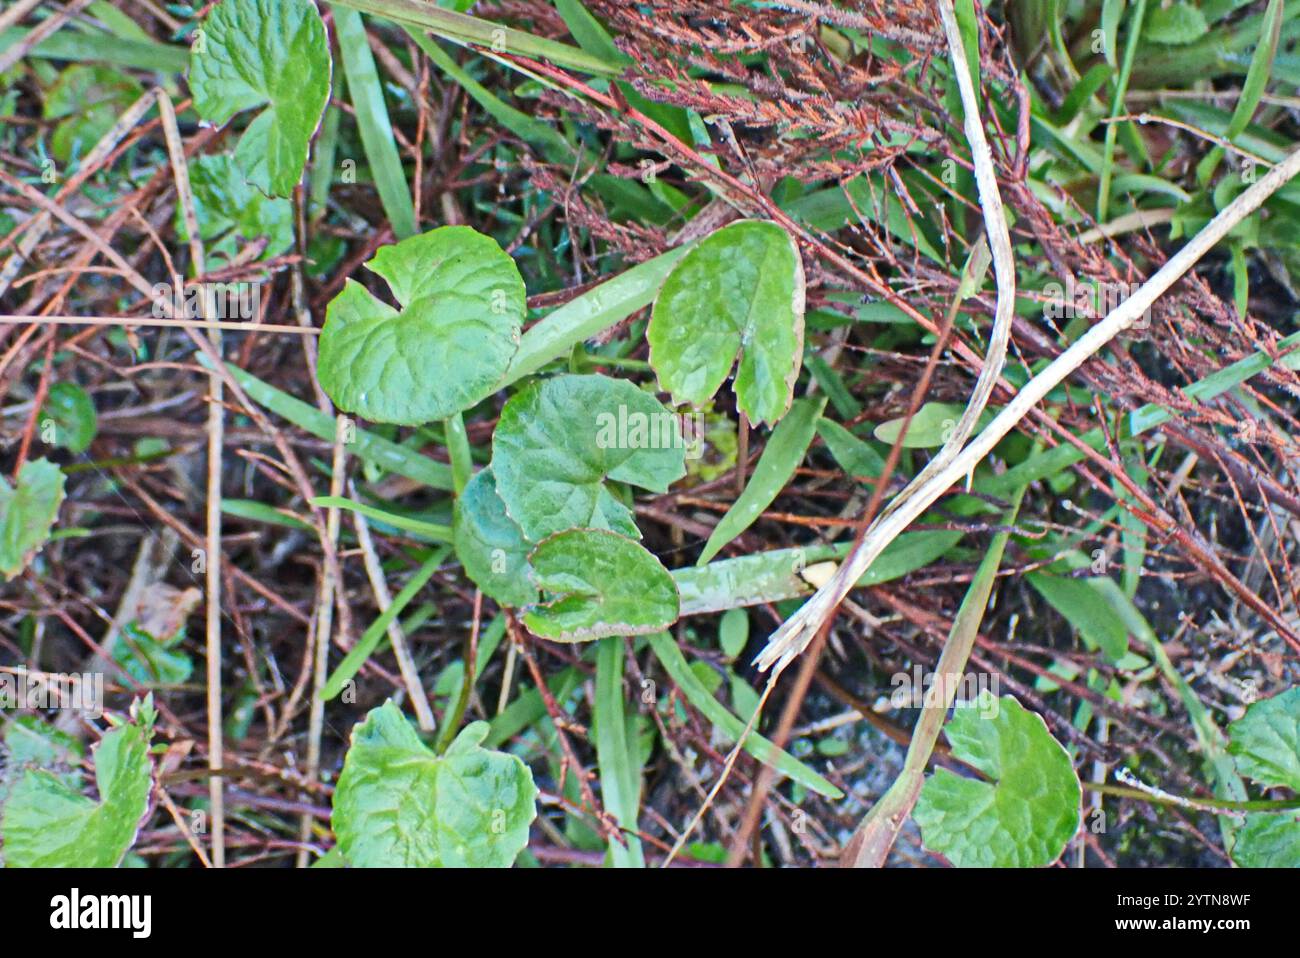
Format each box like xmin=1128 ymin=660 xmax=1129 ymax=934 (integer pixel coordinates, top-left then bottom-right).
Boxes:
xmin=524 ymin=529 xmax=679 ymax=642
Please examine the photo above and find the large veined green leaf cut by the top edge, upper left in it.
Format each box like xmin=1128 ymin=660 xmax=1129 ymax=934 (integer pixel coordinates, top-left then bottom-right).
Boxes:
xmin=190 ymin=0 xmax=330 ymax=196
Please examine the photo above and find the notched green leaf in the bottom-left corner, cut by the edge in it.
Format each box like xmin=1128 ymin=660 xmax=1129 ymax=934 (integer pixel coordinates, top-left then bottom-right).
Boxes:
xmin=0 ymin=707 xmax=152 ymax=868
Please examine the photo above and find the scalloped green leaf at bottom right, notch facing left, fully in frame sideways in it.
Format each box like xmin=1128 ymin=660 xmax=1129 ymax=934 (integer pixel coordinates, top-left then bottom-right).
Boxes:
xmin=913 ymin=693 xmax=1083 ymax=868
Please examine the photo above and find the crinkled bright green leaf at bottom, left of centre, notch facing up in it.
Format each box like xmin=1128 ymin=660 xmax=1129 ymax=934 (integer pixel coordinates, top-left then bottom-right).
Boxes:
xmin=332 ymin=702 xmax=537 ymax=868
